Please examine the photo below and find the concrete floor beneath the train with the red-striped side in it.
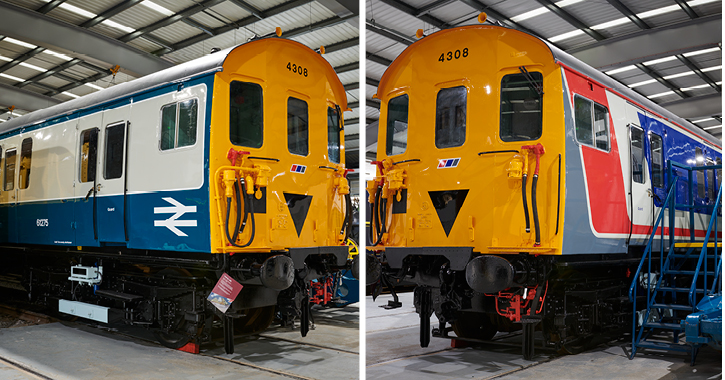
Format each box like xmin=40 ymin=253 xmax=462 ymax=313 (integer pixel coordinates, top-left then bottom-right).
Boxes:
xmin=365 ymin=293 xmax=722 ymax=380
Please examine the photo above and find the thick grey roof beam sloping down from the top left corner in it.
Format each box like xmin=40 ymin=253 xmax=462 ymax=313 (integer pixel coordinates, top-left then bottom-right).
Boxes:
xmin=0 ymin=2 xmax=173 ymax=76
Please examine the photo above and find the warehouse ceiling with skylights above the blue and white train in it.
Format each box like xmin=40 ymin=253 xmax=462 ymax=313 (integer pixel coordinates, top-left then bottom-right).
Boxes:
xmin=0 ymin=0 xmax=360 ymax=167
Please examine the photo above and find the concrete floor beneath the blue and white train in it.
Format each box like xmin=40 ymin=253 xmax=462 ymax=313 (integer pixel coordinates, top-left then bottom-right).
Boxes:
xmin=0 ymin=305 xmax=359 ymax=380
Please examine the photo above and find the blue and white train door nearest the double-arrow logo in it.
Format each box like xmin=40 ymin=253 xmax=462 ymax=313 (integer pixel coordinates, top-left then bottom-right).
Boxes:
xmin=96 ymin=119 xmax=128 ymax=243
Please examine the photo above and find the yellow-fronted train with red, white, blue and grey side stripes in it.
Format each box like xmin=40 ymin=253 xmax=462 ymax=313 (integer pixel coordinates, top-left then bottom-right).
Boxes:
xmin=366 ymin=15 xmax=722 ymax=358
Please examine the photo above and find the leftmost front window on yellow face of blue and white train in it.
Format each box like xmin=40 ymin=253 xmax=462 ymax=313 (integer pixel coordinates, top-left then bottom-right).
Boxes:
xmin=229 ymin=81 xmax=263 ymax=148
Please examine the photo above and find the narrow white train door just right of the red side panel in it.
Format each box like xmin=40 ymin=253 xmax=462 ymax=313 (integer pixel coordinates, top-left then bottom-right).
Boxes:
xmin=629 ymin=123 xmax=653 ymax=238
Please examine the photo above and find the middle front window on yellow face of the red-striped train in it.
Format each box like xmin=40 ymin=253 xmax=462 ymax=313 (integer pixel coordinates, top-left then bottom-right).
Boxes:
xmin=435 ymin=86 xmax=468 ymax=148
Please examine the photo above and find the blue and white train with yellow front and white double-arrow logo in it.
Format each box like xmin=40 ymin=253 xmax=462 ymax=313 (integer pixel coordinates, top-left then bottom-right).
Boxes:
xmin=0 ymin=30 xmax=356 ymax=352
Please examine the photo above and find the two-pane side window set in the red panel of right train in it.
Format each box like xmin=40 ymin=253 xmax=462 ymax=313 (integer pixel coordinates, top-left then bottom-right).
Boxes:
xmin=574 ymin=95 xmax=608 ymax=151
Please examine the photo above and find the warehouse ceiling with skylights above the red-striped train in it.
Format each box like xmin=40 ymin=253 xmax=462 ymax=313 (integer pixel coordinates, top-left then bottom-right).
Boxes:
xmin=365 ymin=0 xmax=722 ymax=159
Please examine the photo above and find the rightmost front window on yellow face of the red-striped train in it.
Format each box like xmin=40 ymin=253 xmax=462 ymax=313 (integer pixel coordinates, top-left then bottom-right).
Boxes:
xmin=500 ymin=71 xmax=543 ymax=141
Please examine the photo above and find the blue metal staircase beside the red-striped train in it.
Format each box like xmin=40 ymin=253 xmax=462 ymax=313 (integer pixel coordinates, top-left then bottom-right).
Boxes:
xmin=629 ymin=161 xmax=722 ymax=365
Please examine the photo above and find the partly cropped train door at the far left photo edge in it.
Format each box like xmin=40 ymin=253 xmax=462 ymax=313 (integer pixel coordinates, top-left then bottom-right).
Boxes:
xmin=0 ymin=143 xmax=19 ymax=243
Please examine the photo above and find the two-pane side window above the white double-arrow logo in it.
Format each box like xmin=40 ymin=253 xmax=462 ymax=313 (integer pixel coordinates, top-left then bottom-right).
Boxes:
xmin=160 ymin=99 xmax=198 ymax=150
